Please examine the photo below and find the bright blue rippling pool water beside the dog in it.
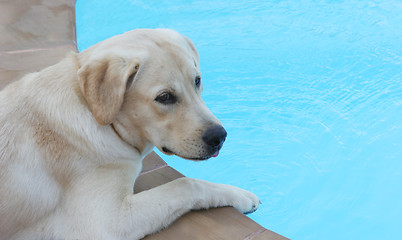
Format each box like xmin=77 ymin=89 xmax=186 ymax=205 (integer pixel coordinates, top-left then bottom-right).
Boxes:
xmin=77 ymin=0 xmax=402 ymax=240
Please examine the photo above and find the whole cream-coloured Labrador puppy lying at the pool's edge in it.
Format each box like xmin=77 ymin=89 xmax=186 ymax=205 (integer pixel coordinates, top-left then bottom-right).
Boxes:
xmin=0 ymin=29 xmax=259 ymax=240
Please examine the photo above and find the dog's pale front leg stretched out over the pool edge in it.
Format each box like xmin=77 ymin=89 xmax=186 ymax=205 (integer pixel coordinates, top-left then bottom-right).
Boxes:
xmin=119 ymin=178 xmax=259 ymax=239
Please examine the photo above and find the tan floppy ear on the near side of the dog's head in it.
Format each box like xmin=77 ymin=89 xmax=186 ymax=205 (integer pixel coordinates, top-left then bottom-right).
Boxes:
xmin=78 ymin=57 xmax=139 ymax=125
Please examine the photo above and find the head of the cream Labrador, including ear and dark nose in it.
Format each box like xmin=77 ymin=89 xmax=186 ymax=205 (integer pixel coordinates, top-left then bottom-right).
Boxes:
xmin=78 ymin=29 xmax=226 ymax=160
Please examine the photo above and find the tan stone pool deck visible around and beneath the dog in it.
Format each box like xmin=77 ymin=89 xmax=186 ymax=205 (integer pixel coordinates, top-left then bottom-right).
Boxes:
xmin=0 ymin=0 xmax=287 ymax=240
